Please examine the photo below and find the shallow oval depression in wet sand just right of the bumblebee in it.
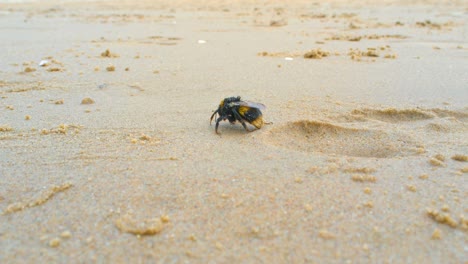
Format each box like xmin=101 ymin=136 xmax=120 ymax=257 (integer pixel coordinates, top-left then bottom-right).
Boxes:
xmin=266 ymin=120 xmax=416 ymax=158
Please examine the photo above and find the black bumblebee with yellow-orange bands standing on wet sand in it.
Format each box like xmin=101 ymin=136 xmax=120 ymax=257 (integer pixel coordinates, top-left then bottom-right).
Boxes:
xmin=210 ymin=96 xmax=266 ymax=134
